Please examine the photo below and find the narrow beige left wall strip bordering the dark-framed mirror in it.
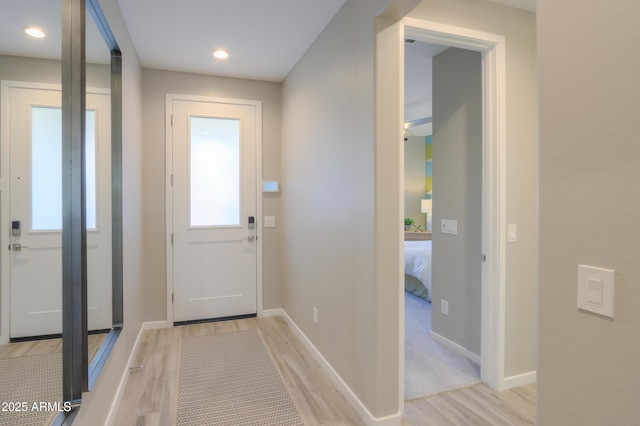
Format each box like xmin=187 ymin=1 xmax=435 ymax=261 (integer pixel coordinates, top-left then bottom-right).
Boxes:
xmin=74 ymin=0 xmax=145 ymax=426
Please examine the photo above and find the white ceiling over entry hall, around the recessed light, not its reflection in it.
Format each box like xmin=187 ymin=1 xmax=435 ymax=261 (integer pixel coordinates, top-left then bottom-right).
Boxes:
xmin=119 ymin=0 xmax=345 ymax=81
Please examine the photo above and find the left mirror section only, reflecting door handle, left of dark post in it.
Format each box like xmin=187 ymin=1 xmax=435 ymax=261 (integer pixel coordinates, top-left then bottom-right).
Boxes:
xmin=0 ymin=4 xmax=63 ymax=424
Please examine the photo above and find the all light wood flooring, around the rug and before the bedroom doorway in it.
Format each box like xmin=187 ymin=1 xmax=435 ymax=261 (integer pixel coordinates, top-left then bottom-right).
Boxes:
xmin=115 ymin=317 xmax=535 ymax=426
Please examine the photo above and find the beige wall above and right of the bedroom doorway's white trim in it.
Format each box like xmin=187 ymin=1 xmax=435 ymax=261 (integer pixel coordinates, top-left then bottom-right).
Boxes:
xmin=409 ymin=0 xmax=538 ymax=377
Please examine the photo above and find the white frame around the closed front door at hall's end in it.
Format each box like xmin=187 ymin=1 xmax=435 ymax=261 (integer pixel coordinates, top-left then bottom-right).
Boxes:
xmin=165 ymin=93 xmax=263 ymax=327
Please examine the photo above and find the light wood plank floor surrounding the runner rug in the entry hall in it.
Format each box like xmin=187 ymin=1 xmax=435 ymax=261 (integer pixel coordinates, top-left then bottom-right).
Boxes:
xmin=115 ymin=317 xmax=363 ymax=426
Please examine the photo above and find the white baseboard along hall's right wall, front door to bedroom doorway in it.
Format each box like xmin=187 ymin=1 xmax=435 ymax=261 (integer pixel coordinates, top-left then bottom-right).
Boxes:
xmin=280 ymin=309 xmax=402 ymax=426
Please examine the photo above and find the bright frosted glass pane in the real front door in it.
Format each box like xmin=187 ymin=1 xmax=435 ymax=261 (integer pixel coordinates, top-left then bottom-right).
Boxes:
xmin=189 ymin=117 xmax=240 ymax=226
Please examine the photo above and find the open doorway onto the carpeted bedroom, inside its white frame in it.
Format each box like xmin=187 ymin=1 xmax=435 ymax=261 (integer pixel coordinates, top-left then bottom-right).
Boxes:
xmin=404 ymin=38 xmax=482 ymax=400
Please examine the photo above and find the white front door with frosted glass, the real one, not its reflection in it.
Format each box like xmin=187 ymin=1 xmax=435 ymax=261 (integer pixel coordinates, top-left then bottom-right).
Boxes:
xmin=172 ymin=100 xmax=257 ymax=322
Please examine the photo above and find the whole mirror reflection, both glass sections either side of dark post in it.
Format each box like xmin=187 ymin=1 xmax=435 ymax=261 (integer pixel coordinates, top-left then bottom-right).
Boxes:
xmin=0 ymin=0 xmax=121 ymax=424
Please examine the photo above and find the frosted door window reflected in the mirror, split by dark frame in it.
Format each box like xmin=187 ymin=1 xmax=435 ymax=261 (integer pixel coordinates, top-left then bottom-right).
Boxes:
xmin=31 ymin=107 xmax=96 ymax=231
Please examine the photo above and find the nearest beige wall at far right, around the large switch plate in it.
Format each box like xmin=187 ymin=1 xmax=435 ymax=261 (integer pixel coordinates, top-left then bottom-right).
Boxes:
xmin=537 ymin=0 xmax=640 ymax=426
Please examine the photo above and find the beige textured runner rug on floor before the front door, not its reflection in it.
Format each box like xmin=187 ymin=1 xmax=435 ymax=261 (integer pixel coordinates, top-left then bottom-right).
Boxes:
xmin=173 ymin=331 xmax=303 ymax=426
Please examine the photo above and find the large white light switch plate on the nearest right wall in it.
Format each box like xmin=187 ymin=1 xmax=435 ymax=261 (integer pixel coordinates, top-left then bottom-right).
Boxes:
xmin=578 ymin=265 xmax=616 ymax=318
